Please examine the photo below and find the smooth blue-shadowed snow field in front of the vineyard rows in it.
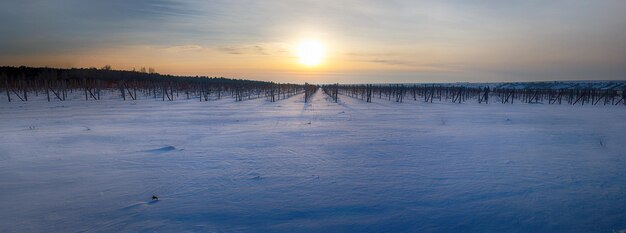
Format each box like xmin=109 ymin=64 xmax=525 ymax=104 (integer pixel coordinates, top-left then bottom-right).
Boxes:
xmin=0 ymin=88 xmax=626 ymax=232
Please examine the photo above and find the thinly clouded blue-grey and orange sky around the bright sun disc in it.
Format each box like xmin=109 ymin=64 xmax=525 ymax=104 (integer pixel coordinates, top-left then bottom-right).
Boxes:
xmin=0 ymin=0 xmax=626 ymax=83
